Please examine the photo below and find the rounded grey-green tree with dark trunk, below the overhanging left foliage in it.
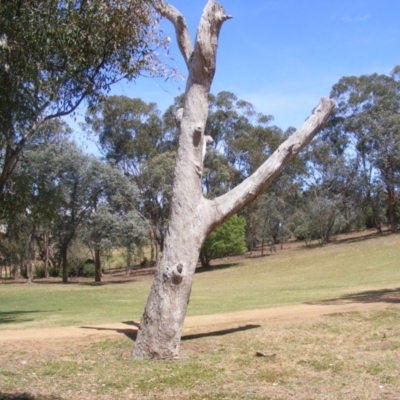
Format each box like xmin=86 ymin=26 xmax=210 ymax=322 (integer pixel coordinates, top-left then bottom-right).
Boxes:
xmin=14 ymin=140 xmax=111 ymax=282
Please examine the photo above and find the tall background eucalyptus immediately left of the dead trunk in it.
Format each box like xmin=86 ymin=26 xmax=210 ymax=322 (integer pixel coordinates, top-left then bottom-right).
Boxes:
xmin=86 ymin=96 xmax=175 ymax=261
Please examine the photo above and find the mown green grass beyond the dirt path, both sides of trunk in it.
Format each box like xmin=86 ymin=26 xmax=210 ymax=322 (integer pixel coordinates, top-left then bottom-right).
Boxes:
xmin=0 ymin=231 xmax=400 ymax=329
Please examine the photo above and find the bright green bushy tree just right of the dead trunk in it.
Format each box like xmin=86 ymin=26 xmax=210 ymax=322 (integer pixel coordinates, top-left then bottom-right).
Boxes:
xmin=200 ymin=215 xmax=246 ymax=267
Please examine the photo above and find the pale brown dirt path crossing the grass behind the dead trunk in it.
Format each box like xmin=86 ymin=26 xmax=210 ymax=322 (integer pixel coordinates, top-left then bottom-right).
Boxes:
xmin=0 ymin=296 xmax=400 ymax=354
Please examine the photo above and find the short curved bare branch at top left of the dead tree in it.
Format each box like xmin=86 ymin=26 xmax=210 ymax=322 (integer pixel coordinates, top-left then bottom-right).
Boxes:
xmin=155 ymin=2 xmax=193 ymax=68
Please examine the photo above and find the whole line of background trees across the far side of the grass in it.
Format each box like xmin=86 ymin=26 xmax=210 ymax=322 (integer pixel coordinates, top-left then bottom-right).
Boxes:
xmin=0 ymin=62 xmax=400 ymax=280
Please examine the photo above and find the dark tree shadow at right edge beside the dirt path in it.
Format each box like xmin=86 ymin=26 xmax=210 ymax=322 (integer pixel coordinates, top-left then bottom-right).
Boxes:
xmin=306 ymin=288 xmax=400 ymax=305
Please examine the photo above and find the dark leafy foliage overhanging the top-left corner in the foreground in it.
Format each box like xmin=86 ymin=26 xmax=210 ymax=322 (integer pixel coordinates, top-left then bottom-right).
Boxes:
xmin=0 ymin=0 xmax=167 ymax=196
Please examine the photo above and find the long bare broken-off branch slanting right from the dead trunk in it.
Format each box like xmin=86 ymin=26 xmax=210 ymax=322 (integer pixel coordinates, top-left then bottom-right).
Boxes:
xmin=208 ymin=98 xmax=335 ymax=229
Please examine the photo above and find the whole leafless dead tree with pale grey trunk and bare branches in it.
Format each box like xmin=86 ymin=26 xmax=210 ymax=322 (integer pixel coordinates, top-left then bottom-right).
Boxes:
xmin=132 ymin=0 xmax=334 ymax=359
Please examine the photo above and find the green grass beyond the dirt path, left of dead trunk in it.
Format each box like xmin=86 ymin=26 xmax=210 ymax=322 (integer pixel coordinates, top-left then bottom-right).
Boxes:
xmin=0 ymin=281 xmax=150 ymax=329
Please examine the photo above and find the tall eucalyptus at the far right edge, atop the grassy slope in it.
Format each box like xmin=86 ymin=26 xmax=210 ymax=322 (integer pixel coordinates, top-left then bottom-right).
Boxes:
xmin=331 ymin=67 xmax=400 ymax=232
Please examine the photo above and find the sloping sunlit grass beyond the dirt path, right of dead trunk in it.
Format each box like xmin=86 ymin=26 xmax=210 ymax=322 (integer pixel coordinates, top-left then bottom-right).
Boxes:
xmin=189 ymin=235 xmax=400 ymax=315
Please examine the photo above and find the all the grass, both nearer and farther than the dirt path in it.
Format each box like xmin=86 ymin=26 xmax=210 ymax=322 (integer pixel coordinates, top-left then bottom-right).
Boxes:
xmin=0 ymin=231 xmax=400 ymax=400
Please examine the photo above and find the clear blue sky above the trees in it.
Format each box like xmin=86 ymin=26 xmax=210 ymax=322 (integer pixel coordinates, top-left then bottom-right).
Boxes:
xmin=71 ymin=0 xmax=400 ymax=150
